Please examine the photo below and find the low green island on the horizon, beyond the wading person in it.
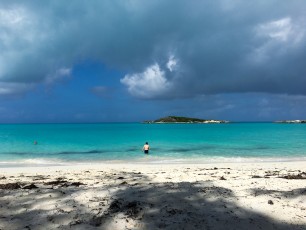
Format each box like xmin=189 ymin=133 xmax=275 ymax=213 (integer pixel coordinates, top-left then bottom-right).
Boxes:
xmin=143 ymin=116 xmax=229 ymax=124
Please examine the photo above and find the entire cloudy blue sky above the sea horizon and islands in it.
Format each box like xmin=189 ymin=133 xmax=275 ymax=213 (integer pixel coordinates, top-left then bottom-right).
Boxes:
xmin=0 ymin=0 xmax=306 ymax=123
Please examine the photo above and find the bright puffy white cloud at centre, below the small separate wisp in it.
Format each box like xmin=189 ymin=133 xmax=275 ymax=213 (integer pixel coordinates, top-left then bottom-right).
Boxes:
xmin=120 ymin=64 xmax=171 ymax=98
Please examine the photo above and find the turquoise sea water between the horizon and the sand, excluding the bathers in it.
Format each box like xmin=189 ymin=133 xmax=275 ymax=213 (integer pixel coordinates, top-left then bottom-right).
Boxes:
xmin=0 ymin=123 xmax=306 ymax=166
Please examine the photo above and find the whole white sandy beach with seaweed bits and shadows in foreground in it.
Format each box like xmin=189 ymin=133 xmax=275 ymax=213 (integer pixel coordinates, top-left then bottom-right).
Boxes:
xmin=0 ymin=162 xmax=306 ymax=230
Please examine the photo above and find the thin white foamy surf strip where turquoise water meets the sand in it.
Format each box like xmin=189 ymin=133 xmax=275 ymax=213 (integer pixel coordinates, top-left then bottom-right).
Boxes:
xmin=0 ymin=155 xmax=306 ymax=169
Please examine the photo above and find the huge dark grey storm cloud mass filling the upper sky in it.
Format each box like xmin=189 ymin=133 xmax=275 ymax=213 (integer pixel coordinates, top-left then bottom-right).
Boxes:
xmin=0 ymin=0 xmax=306 ymax=98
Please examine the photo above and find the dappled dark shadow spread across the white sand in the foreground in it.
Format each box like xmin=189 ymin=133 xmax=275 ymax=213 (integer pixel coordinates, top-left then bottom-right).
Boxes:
xmin=0 ymin=172 xmax=306 ymax=230
